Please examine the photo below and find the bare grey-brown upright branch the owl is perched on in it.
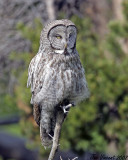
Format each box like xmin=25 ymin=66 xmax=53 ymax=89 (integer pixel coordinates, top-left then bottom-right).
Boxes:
xmin=48 ymin=111 xmax=65 ymax=160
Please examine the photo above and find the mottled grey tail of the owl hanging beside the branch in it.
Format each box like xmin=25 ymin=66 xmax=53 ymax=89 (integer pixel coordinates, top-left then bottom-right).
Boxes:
xmin=40 ymin=110 xmax=55 ymax=147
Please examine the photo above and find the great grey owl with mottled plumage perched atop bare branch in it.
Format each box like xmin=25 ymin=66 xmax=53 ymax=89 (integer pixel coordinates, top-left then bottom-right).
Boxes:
xmin=27 ymin=19 xmax=89 ymax=147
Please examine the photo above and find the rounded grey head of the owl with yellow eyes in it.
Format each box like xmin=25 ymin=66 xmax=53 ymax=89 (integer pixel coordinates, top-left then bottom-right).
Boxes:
xmin=40 ymin=19 xmax=77 ymax=54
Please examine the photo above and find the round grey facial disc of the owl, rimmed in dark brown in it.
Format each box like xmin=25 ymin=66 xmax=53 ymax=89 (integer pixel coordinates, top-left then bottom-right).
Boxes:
xmin=48 ymin=25 xmax=77 ymax=55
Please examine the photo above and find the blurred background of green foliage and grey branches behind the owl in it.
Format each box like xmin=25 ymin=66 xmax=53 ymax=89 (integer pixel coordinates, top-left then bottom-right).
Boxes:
xmin=0 ymin=0 xmax=128 ymax=160
